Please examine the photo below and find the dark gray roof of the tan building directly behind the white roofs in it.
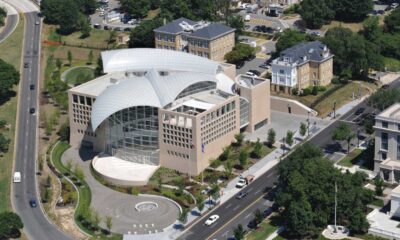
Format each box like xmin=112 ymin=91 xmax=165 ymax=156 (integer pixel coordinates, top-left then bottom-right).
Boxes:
xmin=154 ymin=18 xmax=235 ymax=40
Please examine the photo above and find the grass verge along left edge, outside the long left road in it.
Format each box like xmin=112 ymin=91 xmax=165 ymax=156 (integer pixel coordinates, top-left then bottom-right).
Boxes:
xmin=0 ymin=15 xmax=24 ymax=212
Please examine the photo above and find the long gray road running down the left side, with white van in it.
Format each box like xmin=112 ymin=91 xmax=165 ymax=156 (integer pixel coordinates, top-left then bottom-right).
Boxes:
xmin=11 ymin=12 xmax=71 ymax=240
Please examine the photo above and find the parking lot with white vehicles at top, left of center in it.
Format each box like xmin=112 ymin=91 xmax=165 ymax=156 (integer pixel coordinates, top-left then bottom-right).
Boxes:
xmin=90 ymin=0 xmax=139 ymax=31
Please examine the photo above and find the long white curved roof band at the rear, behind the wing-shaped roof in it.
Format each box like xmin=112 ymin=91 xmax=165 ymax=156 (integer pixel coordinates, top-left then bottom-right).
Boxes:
xmin=101 ymin=48 xmax=219 ymax=74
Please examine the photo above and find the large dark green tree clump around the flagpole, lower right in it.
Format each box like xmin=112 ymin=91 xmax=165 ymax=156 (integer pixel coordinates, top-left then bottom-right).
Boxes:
xmin=275 ymin=143 xmax=373 ymax=238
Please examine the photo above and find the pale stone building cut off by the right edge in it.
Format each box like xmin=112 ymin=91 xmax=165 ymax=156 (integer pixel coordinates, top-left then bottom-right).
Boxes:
xmin=374 ymin=103 xmax=400 ymax=183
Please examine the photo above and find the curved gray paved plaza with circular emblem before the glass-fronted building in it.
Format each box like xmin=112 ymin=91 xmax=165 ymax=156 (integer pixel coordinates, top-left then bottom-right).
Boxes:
xmin=62 ymin=148 xmax=180 ymax=234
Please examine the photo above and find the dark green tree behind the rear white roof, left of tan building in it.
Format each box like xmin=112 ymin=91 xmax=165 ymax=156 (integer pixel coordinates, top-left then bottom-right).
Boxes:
xmin=128 ymin=18 xmax=164 ymax=48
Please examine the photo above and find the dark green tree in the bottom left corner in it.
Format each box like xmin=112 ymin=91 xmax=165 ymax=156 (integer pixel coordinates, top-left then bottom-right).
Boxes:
xmin=0 ymin=212 xmax=24 ymax=239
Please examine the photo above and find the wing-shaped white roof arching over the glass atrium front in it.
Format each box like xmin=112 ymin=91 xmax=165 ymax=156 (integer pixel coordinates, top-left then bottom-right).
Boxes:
xmin=91 ymin=69 xmax=216 ymax=130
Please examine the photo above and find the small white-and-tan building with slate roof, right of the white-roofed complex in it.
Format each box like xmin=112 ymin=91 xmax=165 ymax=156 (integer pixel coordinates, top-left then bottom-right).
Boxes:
xmin=271 ymin=41 xmax=333 ymax=94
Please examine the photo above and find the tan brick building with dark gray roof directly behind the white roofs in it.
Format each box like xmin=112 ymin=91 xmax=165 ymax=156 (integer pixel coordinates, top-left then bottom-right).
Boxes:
xmin=154 ymin=18 xmax=235 ymax=62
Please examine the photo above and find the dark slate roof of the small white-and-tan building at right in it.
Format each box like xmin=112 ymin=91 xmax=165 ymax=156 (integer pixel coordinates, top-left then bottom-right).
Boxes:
xmin=278 ymin=41 xmax=333 ymax=64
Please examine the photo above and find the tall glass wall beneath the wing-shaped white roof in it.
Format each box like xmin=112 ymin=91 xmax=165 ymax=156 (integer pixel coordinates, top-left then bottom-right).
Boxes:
xmin=106 ymin=106 xmax=159 ymax=165
